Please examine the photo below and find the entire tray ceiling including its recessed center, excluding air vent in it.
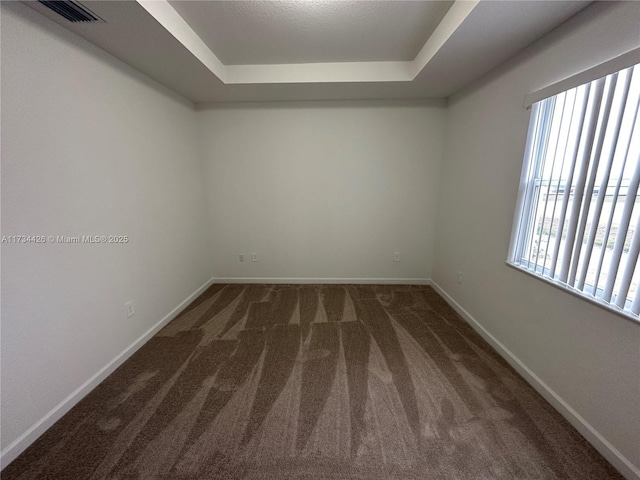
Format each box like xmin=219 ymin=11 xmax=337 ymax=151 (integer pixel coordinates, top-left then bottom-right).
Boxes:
xmin=25 ymin=0 xmax=591 ymax=103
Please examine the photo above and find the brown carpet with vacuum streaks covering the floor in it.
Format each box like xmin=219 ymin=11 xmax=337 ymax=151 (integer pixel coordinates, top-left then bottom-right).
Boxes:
xmin=2 ymin=285 xmax=622 ymax=480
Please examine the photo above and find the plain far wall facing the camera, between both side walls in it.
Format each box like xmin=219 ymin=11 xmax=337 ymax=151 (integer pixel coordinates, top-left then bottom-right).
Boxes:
xmin=199 ymin=102 xmax=444 ymax=279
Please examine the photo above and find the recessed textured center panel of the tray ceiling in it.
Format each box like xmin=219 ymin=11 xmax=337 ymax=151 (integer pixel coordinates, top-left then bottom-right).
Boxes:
xmin=169 ymin=0 xmax=453 ymax=65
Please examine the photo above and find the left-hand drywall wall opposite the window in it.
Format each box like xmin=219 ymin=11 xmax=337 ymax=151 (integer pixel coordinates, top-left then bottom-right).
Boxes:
xmin=1 ymin=2 xmax=209 ymax=458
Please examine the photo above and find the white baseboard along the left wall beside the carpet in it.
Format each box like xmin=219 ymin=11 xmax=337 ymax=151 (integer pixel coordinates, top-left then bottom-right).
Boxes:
xmin=0 ymin=278 xmax=214 ymax=470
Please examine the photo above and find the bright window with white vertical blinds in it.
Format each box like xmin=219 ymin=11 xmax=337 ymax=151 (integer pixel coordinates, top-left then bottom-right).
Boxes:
xmin=508 ymin=61 xmax=640 ymax=320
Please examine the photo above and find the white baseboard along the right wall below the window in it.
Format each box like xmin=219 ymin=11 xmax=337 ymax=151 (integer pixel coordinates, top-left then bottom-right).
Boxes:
xmin=431 ymin=281 xmax=640 ymax=480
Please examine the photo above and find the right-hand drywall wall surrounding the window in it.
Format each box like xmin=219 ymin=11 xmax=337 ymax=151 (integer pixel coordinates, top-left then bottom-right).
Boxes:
xmin=433 ymin=2 xmax=640 ymax=468
